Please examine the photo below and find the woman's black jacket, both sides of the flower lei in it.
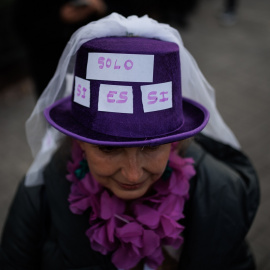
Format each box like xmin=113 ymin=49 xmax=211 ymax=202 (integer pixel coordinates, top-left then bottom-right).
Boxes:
xmin=0 ymin=136 xmax=259 ymax=270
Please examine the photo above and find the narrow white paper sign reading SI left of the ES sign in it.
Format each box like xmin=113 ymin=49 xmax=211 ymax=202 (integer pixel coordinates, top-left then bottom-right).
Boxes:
xmin=74 ymin=76 xmax=90 ymax=108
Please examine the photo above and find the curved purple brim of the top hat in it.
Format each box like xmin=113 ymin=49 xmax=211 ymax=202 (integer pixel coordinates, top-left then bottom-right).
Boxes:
xmin=44 ymin=96 xmax=209 ymax=147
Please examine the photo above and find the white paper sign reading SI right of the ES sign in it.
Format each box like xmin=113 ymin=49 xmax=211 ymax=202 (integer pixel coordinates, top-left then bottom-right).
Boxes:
xmin=141 ymin=82 xmax=172 ymax=112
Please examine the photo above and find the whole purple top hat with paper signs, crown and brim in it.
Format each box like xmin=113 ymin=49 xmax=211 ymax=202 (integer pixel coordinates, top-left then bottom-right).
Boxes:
xmin=45 ymin=37 xmax=209 ymax=146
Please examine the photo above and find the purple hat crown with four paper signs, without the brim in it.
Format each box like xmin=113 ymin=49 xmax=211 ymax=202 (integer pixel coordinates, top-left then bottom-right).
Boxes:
xmin=72 ymin=37 xmax=184 ymax=138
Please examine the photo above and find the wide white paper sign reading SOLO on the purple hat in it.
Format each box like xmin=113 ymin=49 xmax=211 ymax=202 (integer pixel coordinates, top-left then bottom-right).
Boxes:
xmin=86 ymin=53 xmax=154 ymax=82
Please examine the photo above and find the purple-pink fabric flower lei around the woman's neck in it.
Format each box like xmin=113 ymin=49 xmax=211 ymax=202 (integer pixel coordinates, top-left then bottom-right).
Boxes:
xmin=67 ymin=142 xmax=195 ymax=269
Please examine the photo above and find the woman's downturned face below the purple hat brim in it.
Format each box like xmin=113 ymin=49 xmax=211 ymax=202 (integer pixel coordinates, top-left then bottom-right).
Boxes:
xmin=79 ymin=141 xmax=171 ymax=200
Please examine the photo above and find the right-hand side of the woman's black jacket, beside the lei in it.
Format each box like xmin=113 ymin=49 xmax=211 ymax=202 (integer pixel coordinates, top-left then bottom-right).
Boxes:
xmin=179 ymin=135 xmax=259 ymax=269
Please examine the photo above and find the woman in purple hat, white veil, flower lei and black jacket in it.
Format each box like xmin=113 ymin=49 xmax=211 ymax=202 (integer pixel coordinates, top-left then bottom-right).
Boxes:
xmin=0 ymin=14 xmax=259 ymax=270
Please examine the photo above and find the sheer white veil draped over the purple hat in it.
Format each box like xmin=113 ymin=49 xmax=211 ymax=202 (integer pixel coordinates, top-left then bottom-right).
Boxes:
xmin=25 ymin=13 xmax=240 ymax=186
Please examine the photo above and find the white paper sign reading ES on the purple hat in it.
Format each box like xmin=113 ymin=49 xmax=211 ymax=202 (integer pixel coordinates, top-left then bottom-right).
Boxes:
xmin=98 ymin=84 xmax=133 ymax=113
